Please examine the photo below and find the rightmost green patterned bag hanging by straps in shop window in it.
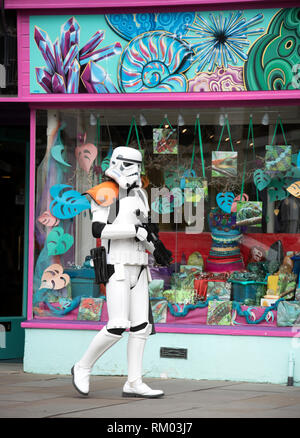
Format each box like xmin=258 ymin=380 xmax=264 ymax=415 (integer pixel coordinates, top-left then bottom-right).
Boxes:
xmin=265 ymin=117 xmax=292 ymax=178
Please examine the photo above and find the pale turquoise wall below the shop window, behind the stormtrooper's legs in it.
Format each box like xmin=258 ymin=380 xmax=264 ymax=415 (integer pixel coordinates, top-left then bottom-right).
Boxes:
xmin=24 ymin=329 xmax=300 ymax=386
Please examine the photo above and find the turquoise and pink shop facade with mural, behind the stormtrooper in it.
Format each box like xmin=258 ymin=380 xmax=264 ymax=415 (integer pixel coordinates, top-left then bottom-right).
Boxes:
xmin=6 ymin=0 xmax=300 ymax=383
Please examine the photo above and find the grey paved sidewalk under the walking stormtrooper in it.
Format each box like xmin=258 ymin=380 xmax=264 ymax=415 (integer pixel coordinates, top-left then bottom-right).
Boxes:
xmin=0 ymin=361 xmax=300 ymax=424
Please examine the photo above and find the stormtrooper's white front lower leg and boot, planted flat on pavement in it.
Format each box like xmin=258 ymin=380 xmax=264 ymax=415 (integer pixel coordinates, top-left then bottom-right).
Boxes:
xmin=122 ymin=324 xmax=164 ymax=398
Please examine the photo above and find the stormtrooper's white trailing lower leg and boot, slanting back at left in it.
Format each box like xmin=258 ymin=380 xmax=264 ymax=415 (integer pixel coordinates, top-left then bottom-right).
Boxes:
xmin=71 ymin=327 xmax=122 ymax=395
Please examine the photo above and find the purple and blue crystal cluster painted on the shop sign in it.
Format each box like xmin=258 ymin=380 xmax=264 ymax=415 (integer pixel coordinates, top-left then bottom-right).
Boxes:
xmin=34 ymin=17 xmax=122 ymax=93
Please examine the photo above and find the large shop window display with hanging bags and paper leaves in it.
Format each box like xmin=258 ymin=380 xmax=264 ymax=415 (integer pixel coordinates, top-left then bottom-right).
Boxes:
xmin=32 ymin=107 xmax=300 ymax=326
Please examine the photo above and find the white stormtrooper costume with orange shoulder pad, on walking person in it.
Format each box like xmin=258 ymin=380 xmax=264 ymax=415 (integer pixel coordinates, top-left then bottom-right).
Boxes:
xmin=72 ymin=146 xmax=164 ymax=398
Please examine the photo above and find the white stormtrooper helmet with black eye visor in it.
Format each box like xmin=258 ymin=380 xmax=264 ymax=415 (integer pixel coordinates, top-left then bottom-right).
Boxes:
xmin=105 ymin=146 xmax=143 ymax=189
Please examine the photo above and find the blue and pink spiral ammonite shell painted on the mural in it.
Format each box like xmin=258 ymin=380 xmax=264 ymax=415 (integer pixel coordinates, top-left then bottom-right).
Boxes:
xmin=118 ymin=31 xmax=194 ymax=93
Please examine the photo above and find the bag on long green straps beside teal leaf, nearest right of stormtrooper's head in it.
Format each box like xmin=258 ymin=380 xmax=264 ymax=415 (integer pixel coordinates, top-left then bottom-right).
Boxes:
xmin=180 ymin=117 xmax=208 ymax=203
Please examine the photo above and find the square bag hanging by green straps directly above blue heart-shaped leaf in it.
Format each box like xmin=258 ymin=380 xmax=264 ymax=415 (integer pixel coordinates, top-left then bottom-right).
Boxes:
xmin=211 ymin=117 xmax=238 ymax=178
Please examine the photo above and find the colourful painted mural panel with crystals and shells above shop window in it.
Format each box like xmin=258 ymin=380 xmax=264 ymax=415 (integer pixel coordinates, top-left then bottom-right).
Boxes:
xmin=30 ymin=8 xmax=300 ymax=94
